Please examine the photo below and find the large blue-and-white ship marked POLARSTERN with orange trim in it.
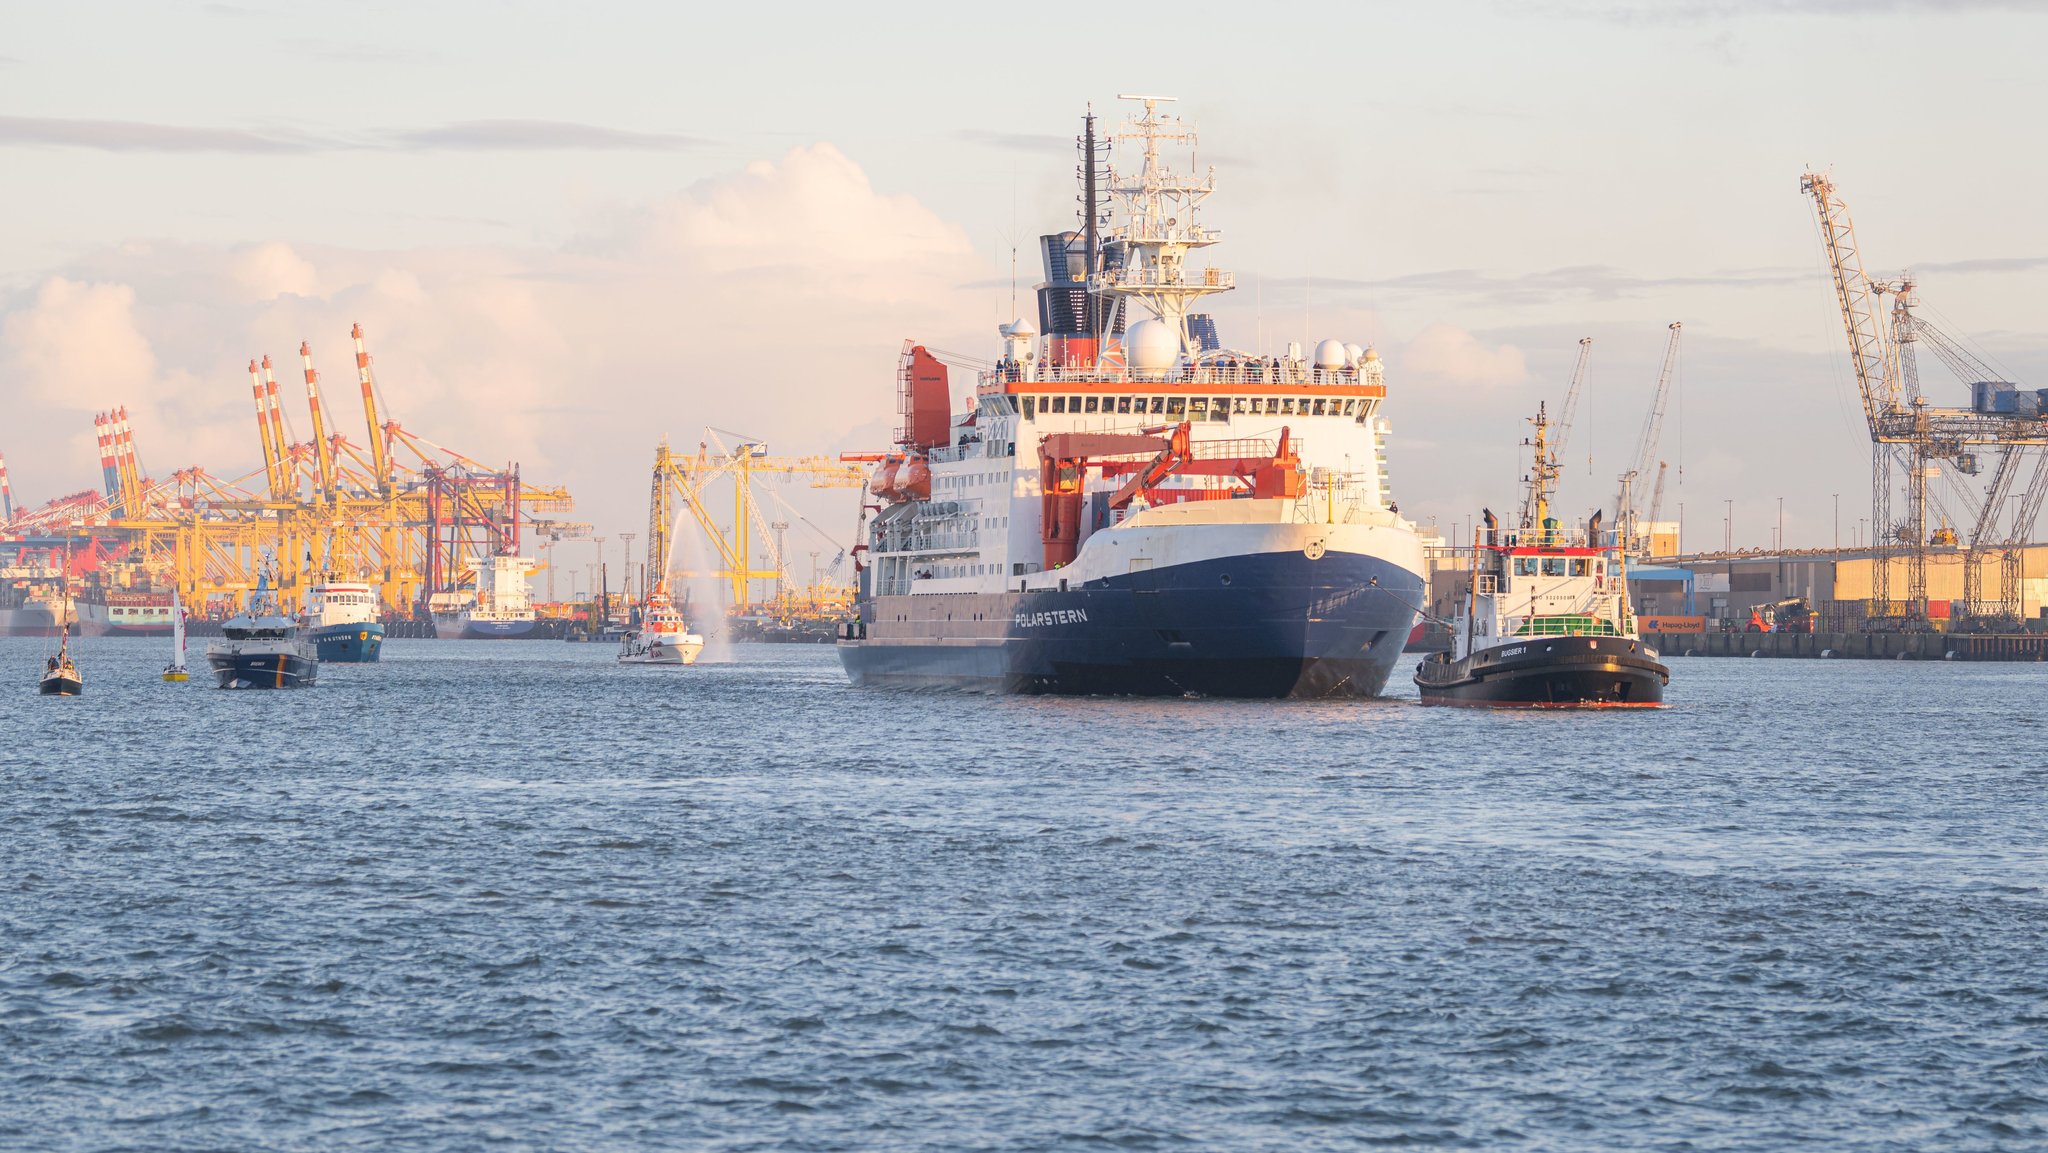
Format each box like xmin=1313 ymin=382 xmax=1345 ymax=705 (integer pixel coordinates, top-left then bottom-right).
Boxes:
xmin=838 ymin=96 xmax=1423 ymax=696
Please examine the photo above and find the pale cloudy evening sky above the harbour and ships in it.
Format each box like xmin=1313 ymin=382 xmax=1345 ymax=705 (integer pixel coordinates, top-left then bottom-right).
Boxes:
xmin=0 ymin=0 xmax=2048 ymax=561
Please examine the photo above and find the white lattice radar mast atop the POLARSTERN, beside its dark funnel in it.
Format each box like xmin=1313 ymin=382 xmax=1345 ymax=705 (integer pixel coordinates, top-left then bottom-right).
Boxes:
xmin=1087 ymin=94 xmax=1235 ymax=354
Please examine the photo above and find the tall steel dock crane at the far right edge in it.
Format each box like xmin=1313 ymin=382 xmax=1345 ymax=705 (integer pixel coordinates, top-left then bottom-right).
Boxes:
xmin=1800 ymin=172 xmax=2048 ymax=629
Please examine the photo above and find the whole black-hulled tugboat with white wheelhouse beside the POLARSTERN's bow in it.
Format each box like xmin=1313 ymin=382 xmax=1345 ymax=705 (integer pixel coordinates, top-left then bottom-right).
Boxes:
xmin=1415 ymin=410 xmax=1671 ymax=709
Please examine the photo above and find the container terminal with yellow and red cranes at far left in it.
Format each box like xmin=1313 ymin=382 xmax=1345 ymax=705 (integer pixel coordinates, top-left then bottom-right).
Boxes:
xmin=0 ymin=326 xmax=588 ymax=635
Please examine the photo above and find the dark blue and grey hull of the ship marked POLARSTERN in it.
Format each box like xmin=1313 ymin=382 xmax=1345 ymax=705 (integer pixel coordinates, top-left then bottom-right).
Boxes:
xmin=840 ymin=553 xmax=1423 ymax=696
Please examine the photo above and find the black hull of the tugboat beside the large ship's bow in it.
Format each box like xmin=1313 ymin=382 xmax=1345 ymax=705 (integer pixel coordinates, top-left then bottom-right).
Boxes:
xmin=1415 ymin=637 xmax=1671 ymax=709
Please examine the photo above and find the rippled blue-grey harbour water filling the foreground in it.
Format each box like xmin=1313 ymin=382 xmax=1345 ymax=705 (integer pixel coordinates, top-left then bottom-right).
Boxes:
xmin=0 ymin=639 xmax=2048 ymax=1151
